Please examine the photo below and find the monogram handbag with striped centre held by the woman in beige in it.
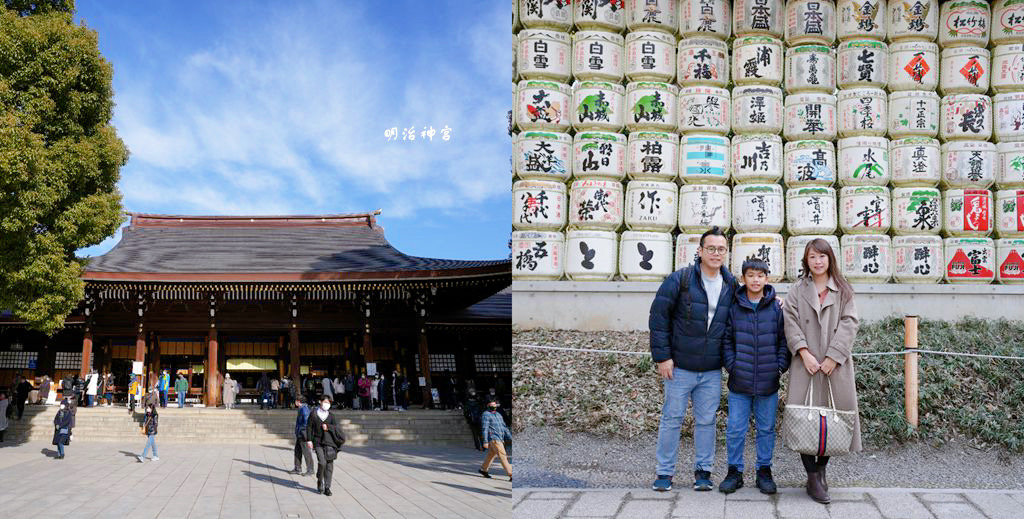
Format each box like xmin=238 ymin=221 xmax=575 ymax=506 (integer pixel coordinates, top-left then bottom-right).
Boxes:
xmin=782 ymin=377 xmax=857 ymax=456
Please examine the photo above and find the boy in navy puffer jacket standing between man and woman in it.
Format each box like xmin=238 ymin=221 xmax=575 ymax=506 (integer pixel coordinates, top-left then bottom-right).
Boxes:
xmin=718 ymin=259 xmax=791 ymax=494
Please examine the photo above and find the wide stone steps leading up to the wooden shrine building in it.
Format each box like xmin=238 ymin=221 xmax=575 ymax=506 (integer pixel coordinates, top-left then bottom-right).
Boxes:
xmin=4 ymin=405 xmax=473 ymax=446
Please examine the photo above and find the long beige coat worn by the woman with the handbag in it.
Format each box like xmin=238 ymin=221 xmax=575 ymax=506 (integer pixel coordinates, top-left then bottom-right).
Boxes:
xmin=783 ymin=277 xmax=861 ymax=451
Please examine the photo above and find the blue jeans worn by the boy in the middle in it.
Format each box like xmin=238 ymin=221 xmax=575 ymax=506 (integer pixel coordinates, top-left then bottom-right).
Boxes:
xmin=725 ymin=391 xmax=778 ymax=472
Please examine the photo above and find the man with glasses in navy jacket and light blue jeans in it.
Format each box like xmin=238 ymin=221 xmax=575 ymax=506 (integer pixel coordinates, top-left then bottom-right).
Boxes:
xmin=649 ymin=227 xmax=736 ymax=491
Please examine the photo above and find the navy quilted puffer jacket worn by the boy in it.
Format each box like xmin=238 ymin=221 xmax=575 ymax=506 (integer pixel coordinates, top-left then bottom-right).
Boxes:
xmin=724 ymin=285 xmax=792 ymax=396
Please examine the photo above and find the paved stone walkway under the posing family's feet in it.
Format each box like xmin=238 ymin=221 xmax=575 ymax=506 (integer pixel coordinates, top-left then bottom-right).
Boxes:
xmin=512 ymin=487 xmax=1024 ymax=519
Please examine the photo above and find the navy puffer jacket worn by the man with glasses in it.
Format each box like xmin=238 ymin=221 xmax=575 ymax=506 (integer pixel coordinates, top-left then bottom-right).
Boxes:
xmin=648 ymin=259 xmax=736 ymax=372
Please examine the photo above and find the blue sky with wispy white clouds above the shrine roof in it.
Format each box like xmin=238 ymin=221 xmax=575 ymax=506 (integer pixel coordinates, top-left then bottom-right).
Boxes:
xmin=77 ymin=0 xmax=514 ymax=259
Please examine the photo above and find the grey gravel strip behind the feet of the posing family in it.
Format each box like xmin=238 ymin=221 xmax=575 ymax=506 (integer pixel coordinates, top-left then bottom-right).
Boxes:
xmin=514 ymin=427 xmax=1024 ymax=489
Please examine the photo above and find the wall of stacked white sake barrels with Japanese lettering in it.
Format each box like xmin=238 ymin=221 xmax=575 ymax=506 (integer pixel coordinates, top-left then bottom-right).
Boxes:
xmin=512 ymin=0 xmax=1024 ymax=284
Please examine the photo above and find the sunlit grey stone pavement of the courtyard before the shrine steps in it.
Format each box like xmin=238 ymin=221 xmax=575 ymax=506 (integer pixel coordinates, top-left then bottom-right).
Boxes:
xmin=0 ymin=436 xmax=512 ymax=519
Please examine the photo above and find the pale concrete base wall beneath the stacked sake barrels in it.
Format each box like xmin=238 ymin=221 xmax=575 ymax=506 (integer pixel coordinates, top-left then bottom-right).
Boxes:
xmin=512 ymin=282 xmax=1024 ymax=331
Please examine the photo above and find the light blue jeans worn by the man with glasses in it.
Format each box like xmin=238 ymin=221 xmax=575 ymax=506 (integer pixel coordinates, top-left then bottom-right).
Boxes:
xmin=657 ymin=367 xmax=722 ymax=476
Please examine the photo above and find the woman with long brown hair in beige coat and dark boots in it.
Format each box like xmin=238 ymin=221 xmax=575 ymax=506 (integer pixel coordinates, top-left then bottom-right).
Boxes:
xmin=783 ymin=239 xmax=861 ymax=503
